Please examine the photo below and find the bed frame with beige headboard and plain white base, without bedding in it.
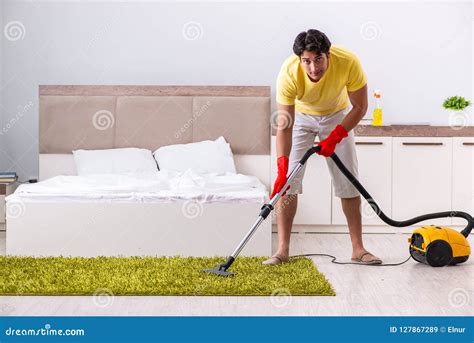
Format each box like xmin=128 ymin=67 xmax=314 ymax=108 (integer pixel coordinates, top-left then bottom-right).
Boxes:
xmin=6 ymin=86 xmax=271 ymax=257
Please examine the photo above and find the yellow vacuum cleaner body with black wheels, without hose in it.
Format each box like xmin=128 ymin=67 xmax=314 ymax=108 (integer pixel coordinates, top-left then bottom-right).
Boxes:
xmin=408 ymin=225 xmax=471 ymax=267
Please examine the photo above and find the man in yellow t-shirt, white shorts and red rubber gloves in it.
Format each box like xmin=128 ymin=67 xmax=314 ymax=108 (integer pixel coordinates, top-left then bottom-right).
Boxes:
xmin=263 ymin=30 xmax=382 ymax=265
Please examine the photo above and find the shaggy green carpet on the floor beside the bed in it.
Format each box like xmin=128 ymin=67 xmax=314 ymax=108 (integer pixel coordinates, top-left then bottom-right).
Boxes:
xmin=0 ymin=256 xmax=335 ymax=295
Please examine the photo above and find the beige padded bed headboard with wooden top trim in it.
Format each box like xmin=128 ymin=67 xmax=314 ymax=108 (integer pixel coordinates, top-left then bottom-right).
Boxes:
xmin=39 ymin=85 xmax=271 ymax=186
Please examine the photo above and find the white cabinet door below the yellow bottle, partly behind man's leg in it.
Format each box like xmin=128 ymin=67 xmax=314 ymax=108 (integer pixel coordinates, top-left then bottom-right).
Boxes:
xmin=332 ymin=137 xmax=392 ymax=225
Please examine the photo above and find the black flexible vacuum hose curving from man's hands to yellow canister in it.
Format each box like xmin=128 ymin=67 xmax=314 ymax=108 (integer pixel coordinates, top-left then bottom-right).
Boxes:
xmin=330 ymin=153 xmax=473 ymax=237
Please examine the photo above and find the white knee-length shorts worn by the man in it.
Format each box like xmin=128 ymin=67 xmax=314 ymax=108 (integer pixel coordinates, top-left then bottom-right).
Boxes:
xmin=287 ymin=109 xmax=359 ymax=198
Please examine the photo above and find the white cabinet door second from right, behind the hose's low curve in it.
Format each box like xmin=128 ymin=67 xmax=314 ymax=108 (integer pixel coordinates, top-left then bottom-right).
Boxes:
xmin=392 ymin=137 xmax=452 ymax=225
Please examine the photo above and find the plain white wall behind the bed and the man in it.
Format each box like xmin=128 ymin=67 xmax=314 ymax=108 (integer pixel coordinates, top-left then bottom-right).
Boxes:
xmin=1 ymin=0 xmax=472 ymax=179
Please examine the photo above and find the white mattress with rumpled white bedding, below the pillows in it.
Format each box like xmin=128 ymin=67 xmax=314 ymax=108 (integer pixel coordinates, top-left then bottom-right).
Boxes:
xmin=5 ymin=170 xmax=268 ymax=203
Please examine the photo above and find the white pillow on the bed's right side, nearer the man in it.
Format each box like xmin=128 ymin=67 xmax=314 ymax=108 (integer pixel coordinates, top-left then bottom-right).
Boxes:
xmin=153 ymin=136 xmax=236 ymax=174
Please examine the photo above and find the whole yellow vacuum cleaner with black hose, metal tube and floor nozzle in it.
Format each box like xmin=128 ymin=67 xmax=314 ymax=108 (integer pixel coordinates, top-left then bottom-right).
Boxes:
xmin=204 ymin=146 xmax=473 ymax=276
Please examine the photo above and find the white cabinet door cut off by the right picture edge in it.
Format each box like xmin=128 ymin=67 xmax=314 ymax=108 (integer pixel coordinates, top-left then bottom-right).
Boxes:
xmin=452 ymin=137 xmax=474 ymax=225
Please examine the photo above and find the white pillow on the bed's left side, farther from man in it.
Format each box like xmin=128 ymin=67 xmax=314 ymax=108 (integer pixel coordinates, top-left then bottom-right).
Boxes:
xmin=72 ymin=148 xmax=158 ymax=176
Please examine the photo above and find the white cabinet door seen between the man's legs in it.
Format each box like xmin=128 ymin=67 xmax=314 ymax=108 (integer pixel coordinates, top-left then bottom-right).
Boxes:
xmin=271 ymin=136 xmax=331 ymax=225
